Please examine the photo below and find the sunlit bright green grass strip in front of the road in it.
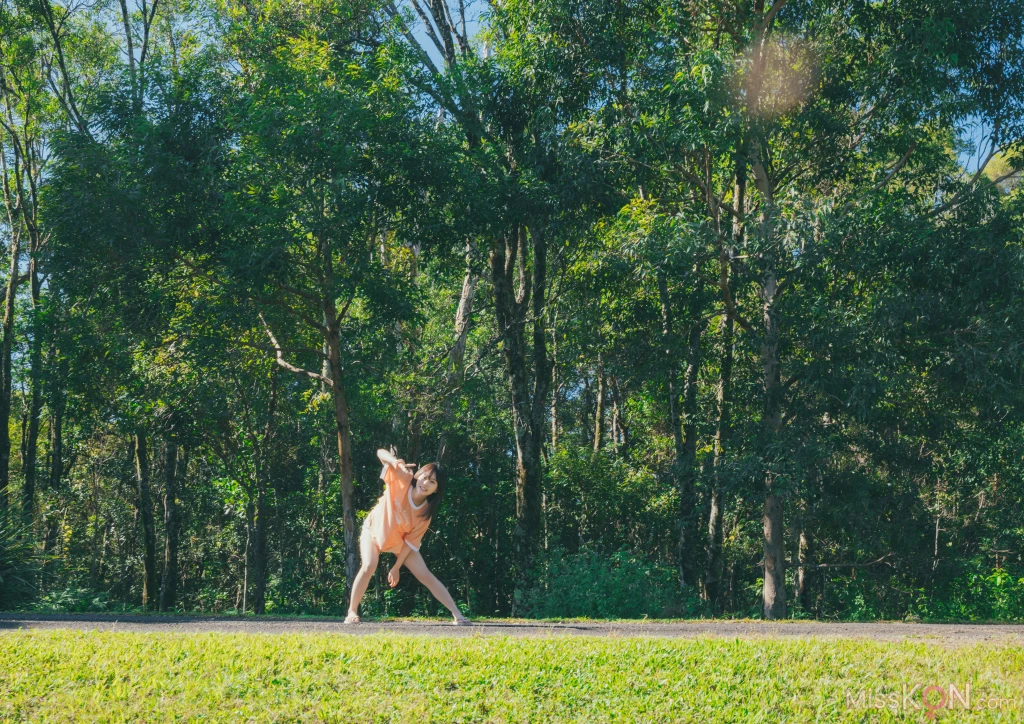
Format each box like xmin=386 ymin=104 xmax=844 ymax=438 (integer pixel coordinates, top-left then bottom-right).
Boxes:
xmin=0 ymin=631 xmax=1024 ymax=724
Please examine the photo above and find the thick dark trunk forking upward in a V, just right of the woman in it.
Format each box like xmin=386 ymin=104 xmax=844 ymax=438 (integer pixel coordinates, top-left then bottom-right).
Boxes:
xmin=489 ymin=223 xmax=551 ymax=610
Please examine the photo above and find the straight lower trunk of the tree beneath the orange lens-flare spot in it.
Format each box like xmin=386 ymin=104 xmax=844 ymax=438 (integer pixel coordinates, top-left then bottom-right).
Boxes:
xmin=761 ymin=270 xmax=785 ymax=619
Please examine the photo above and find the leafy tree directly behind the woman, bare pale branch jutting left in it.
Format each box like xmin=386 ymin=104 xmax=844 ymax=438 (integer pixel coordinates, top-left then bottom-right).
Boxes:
xmin=222 ymin=3 xmax=452 ymax=602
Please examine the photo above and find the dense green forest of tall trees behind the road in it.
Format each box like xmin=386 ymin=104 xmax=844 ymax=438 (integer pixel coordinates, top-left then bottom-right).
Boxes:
xmin=0 ymin=0 xmax=1024 ymax=621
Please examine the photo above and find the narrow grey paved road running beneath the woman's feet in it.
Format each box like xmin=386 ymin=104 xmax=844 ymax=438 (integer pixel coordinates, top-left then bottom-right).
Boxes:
xmin=0 ymin=613 xmax=1024 ymax=646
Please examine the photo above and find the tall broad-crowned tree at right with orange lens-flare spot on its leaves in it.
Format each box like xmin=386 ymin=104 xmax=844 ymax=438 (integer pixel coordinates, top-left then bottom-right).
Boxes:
xmin=598 ymin=0 xmax=1021 ymax=619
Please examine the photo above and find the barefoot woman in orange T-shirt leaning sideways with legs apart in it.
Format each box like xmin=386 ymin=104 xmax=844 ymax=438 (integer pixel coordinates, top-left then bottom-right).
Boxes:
xmin=345 ymin=450 xmax=469 ymax=626
